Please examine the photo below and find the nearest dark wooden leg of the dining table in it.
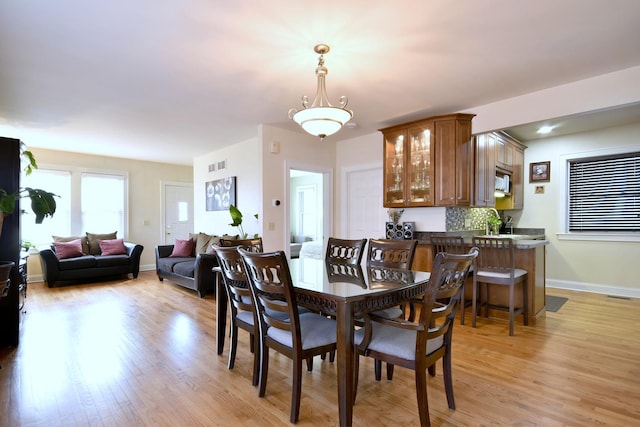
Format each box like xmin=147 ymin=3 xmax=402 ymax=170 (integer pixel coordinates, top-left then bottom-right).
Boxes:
xmin=336 ymin=302 xmax=355 ymax=427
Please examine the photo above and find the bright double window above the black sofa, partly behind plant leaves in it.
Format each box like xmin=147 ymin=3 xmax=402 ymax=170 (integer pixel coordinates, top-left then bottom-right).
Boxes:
xmin=21 ymin=167 xmax=128 ymax=246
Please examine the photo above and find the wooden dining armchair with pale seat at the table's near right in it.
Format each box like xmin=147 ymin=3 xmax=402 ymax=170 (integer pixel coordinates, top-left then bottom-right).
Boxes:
xmin=354 ymin=248 xmax=478 ymax=426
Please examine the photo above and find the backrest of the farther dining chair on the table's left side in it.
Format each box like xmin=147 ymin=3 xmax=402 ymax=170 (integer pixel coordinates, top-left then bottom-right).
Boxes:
xmin=215 ymin=246 xmax=254 ymax=312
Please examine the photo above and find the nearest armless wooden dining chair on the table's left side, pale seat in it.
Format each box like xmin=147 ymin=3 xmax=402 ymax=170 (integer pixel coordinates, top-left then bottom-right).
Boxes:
xmin=238 ymin=248 xmax=337 ymax=423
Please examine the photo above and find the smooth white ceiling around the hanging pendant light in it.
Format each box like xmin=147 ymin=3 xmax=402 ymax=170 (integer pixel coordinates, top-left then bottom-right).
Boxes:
xmin=0 ymin=0 xmax=640 ymax=165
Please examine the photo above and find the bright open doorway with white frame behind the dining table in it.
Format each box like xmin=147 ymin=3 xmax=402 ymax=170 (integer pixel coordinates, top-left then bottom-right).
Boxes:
xmin=285 ymin=165 xmax=333 ymax=258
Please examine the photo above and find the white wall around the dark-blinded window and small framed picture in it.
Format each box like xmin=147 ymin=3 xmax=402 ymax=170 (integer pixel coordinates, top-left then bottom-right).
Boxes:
xmin=510 ymin=123 xmax=640 ymax=297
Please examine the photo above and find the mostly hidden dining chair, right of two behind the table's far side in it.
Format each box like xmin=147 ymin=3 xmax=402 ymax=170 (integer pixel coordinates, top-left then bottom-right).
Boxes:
xmin=367 ymin=239 xmax=418 ymax=381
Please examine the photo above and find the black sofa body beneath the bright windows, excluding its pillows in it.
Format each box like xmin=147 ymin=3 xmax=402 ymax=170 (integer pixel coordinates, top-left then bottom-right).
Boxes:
xmin=40 ymin=242 xmax=144 ymax=288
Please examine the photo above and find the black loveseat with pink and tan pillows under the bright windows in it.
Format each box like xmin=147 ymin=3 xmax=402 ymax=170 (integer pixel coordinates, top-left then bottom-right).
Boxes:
xmin=39 ymin=233 xmax=144 ymax=288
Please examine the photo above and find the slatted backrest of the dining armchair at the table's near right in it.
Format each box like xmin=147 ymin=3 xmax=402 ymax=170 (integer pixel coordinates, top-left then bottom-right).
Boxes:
xmin=418 ymin=247 xmax=478 ymax=342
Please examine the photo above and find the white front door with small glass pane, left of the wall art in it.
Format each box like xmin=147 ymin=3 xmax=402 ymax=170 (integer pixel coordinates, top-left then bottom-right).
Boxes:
xmin=163 ymin=183 xmax=193 ymax=245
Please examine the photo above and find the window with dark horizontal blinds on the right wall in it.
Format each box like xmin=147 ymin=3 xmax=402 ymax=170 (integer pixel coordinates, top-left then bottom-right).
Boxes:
xmin=568 ymin=153 xmax=640 ymax=232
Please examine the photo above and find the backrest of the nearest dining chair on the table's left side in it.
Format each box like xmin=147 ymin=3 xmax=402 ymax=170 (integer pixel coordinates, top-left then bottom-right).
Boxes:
xmin=237 ymin=248 xmax=302 ymax=351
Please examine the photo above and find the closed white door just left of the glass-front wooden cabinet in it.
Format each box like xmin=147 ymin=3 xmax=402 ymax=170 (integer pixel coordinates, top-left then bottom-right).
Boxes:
xmin=346 ymin=167 xmax=388 ymax=239
